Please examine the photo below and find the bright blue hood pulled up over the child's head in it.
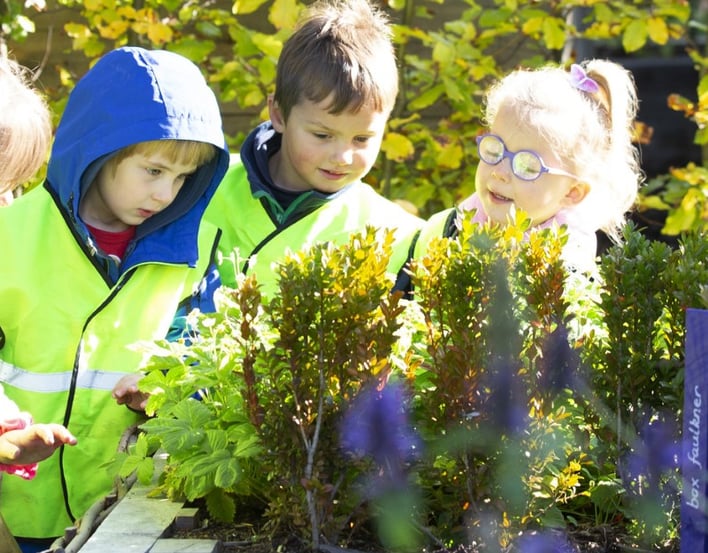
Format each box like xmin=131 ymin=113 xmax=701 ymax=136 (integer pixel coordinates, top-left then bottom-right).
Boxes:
xmin=45 ymin=47 xmax=229 ymax=272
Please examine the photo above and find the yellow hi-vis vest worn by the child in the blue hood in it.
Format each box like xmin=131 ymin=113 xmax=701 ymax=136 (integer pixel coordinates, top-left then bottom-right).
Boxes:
xmin=0 ymin=191 xmax=214 ymax=538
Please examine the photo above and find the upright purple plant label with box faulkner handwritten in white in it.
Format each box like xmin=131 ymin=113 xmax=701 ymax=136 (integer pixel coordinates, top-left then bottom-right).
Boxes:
xmin=681 ymin=309 xmax=708 ymax=553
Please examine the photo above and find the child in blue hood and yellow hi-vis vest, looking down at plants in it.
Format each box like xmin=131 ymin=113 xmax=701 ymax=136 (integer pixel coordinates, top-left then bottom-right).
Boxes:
xmin=0 ymin=47 xmax=229 ymax=551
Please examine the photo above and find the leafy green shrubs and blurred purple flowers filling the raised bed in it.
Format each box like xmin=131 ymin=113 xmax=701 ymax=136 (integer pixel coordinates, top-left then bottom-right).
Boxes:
xmin=117 ymin=219 xmax=708 ymax=551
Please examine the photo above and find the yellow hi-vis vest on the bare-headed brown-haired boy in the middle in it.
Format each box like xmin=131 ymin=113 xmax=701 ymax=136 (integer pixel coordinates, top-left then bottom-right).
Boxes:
xmin=204 ymin=161 xmax=424 ymax=296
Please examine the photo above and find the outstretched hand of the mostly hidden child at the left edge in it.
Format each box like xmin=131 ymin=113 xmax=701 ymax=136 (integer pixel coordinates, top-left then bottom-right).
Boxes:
xmin=0 ymin=424 xmax=76 ymax=465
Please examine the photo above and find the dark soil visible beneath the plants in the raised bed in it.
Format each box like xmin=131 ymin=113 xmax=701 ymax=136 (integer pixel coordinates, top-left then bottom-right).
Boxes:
xmin=172 ymin=508 xmax=679 ymax=553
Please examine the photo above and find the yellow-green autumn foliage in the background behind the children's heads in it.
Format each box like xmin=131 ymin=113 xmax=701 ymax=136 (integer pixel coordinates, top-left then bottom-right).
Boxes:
xmin=0 ymin=0 xmax=708 ymax=235
